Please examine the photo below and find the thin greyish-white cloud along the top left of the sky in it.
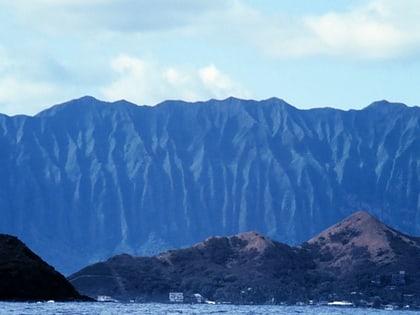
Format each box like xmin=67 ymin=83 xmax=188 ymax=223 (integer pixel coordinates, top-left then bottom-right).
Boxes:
xmin=3 ymin=0 xmax=231 ymax=33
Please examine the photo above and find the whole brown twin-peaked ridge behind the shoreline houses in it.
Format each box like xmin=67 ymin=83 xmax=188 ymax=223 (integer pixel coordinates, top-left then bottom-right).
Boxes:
xmin=69 ymin=212 xmax=420 ymax=303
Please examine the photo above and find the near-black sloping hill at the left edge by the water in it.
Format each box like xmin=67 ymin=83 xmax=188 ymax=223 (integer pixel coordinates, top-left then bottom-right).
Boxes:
xmin=0 ymin=234 xmax=87 ymax=301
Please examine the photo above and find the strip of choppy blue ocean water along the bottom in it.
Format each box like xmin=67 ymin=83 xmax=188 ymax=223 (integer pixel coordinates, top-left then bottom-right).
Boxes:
xmin=0 ymin=302 xmax=420 ymax=315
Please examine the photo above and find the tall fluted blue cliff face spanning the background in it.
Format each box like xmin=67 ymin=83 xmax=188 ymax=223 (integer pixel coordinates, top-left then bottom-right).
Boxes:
xmin=0 ymin=97 xmax=420 ymax=273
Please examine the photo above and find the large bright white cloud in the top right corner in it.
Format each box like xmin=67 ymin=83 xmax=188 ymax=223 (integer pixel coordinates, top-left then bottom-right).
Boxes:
xmin=238 ymin=0 xmax=420 ymax=60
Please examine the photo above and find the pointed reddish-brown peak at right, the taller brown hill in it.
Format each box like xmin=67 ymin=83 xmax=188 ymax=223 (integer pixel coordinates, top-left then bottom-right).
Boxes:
xmin=308 ymin=211 xmax=420 ymax=274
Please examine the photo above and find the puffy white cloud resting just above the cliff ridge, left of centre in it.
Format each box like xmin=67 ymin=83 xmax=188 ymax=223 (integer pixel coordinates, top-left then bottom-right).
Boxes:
xmin=102 ymin=55 xmax=249 ymax=105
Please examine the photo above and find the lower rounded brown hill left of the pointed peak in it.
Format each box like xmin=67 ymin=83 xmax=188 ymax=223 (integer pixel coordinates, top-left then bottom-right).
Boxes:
xmin=69 ymin=232 xmax=313 ymax=303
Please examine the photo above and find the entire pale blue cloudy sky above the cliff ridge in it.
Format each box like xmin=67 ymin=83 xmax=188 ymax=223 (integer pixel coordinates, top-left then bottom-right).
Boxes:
xmin=0 ymin=0 xmax=420 ymax=115
